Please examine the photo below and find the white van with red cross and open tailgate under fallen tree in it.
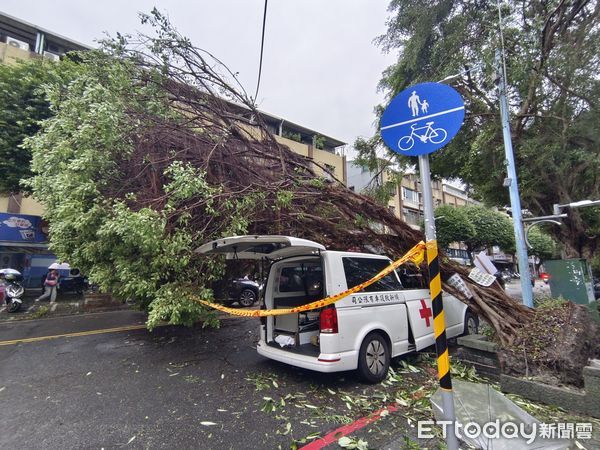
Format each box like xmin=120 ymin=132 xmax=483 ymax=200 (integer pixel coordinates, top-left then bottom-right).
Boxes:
xmin=196 ymin=236 xmax=478 ymax=382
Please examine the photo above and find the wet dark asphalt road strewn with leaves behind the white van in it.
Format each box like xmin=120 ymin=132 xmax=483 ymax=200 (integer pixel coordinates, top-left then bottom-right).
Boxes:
xmin=0 ymin=311 xmax=432 ymax=449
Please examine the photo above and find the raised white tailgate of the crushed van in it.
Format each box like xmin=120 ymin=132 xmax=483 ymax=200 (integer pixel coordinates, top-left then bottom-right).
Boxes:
xmin=195 ymin=235 xmax=325 ymax=260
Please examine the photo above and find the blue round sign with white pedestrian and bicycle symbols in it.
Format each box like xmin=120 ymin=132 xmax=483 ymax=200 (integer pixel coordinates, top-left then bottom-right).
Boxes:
xmin=380 ymin=83 xmax=465 ymax=156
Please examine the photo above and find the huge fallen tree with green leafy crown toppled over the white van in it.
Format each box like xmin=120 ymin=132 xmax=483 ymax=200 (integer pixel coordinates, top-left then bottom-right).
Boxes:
xmin=27 ymin=12 xmax=596 ymax=384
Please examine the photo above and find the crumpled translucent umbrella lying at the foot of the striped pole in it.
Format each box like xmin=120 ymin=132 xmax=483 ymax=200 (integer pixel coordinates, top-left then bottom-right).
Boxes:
xmin=431 ymin=380 xmax=571 ymax=450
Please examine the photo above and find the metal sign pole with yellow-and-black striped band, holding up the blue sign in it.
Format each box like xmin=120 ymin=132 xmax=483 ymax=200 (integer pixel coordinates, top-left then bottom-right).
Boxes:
xmin=419 ymin=154 xmax=458 ymax=450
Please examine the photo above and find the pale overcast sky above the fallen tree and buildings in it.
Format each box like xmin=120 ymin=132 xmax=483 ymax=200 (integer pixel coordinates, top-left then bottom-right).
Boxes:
xmin=0 ymin=0 xmax=395 ymax=150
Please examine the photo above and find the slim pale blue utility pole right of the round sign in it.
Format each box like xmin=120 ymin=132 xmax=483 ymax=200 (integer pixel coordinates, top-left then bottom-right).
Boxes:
xmin=496 ymin=50 xmax=533 ymax=308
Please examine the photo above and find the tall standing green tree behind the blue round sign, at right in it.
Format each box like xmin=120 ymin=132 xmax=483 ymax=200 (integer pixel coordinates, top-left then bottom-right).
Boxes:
xmin=366 ymin=0 xmax=600 ymax=257
